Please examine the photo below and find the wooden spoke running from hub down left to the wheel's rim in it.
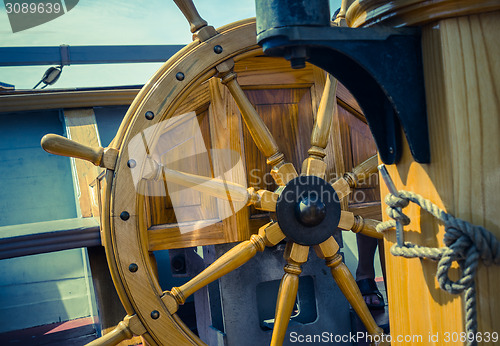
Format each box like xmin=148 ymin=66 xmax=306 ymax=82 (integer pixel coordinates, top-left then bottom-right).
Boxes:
xmin=162 ymin=222 xmax=285 ymax=313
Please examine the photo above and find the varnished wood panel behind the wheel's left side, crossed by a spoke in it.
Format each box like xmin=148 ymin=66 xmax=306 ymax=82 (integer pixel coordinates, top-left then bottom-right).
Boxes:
xmin=146 ymin=78 xmax=250 ymax=250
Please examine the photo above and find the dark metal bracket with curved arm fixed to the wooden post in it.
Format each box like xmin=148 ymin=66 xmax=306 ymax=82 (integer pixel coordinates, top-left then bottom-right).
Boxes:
xmin=256 ymin=0 xmax=430 ymax=164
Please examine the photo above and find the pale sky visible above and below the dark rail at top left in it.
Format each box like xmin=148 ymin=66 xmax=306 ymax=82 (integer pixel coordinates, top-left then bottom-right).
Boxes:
xmin=0 ymin=0 xmax=341 ymax=89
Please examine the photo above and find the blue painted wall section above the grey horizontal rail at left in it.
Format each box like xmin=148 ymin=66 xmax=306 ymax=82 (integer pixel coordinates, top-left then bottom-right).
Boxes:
xmin=0 ymin=110 xmax=76 ymax=226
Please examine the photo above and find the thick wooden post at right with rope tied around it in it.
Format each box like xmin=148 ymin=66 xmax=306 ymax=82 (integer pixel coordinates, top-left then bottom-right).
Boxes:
xmin=347 ymin=0 xmax=500 ymax=345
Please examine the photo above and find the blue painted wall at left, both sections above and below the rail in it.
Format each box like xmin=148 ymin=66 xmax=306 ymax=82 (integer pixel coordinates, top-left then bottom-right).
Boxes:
xmin=0 ymin=110 xmax=91 ymax=332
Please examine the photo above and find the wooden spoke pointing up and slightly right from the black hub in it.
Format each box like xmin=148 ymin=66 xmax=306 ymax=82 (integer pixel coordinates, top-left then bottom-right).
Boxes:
xmin=302 ymin=74 xmax=337 ymax=178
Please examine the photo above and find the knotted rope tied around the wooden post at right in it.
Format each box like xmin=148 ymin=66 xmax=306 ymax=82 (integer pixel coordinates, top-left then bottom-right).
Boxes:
xmin=377 ymin=191 xmax=500 ymax=345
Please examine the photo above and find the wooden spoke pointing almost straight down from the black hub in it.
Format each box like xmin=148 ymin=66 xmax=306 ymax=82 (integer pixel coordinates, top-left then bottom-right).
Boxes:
xmin=271 ymin=241 xmax=309 ymax=346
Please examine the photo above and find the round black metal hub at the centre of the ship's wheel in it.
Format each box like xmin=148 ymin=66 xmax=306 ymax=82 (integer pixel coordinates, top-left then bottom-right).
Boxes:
xmin=276 ymin=175 xmax=340 ymax=245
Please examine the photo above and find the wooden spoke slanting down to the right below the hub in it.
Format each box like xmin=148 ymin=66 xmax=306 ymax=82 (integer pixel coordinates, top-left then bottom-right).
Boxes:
xmin=326 ymin=253 xmax=383 ymax=335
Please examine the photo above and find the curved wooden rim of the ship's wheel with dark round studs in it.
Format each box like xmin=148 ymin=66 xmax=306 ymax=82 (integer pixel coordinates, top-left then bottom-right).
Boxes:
xmin=107 ymin=20 xmax=260 ymax=344
